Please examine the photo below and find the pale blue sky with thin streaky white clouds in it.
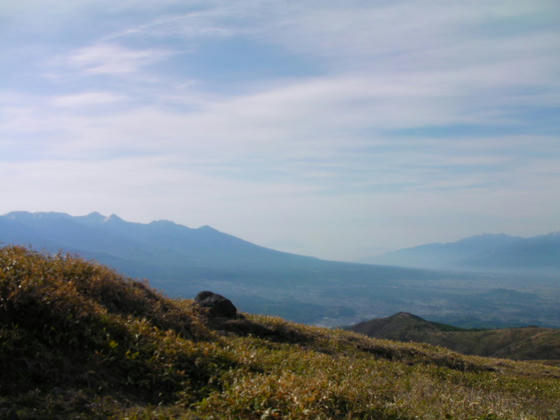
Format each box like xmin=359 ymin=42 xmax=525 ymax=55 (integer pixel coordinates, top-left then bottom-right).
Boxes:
xmin=0 ymin=0 xmax=560 ymax=261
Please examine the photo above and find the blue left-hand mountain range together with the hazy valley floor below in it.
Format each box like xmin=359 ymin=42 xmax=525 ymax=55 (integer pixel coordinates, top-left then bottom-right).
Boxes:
xmin=0 ymin=212 xmax=560 ymax=327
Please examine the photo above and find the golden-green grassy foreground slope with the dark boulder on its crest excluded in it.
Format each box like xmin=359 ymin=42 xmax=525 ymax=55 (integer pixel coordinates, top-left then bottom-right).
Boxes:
xmin=0 ymin=248 xmax=560 ymax=419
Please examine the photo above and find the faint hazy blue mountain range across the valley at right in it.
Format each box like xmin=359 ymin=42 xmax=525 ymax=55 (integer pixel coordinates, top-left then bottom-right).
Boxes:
xmin=362 ymin=233 xmax=560 ymax=272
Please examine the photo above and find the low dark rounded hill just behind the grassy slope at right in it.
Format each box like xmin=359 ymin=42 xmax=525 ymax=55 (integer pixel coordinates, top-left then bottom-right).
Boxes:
xmin=348 ymin=312 xmax=560 ymax=360
